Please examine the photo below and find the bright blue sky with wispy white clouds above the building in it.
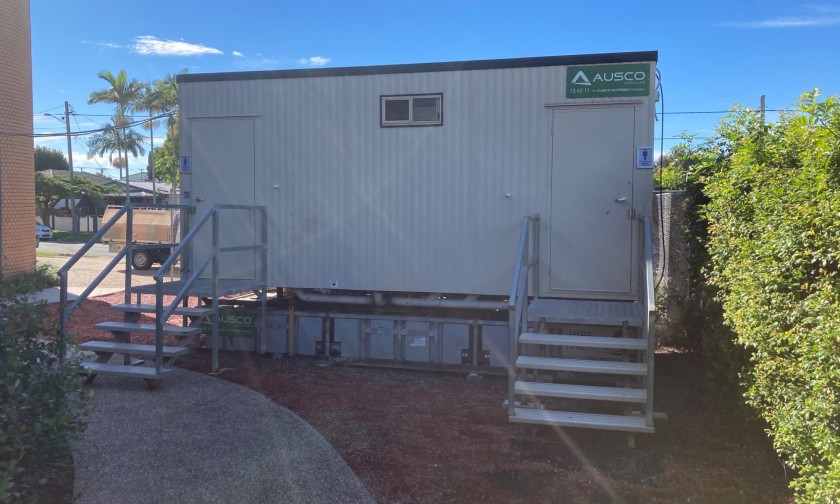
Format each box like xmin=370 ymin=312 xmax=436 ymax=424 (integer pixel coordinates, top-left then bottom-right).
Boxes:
xmin=31 ymin=0 xmax=840 ymax=177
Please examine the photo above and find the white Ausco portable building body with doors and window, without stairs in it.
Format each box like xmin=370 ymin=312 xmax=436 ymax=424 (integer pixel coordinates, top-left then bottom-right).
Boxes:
xmin=178 ymin=52 xmax=657 ymax=300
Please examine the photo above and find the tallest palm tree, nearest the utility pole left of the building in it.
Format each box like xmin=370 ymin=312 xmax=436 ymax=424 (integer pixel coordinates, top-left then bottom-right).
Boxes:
xmin=88 ymin=70 xmax=147 ymax=202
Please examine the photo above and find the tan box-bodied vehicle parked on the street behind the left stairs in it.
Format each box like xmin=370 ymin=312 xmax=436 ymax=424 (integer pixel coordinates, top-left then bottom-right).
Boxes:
xmin=102 ymin=205 xmax=181 ymax=270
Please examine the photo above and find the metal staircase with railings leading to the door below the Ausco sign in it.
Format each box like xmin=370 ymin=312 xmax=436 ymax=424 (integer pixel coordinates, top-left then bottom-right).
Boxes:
xmin=506 ymin=216 xmax=655 ymax=446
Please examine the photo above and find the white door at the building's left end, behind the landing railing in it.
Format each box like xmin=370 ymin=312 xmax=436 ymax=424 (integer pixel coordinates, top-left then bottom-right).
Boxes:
xmin=190 ymin=118 xmax=259 ymax=279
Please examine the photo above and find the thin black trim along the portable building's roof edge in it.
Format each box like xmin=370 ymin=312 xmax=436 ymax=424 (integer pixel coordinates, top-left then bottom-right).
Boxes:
xmin=177 ymin=51 xmax=659 ymax=83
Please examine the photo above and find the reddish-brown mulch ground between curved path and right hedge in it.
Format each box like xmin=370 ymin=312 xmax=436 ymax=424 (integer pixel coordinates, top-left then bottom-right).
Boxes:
xmin=53 ymin=294 xmax=793 ymax=503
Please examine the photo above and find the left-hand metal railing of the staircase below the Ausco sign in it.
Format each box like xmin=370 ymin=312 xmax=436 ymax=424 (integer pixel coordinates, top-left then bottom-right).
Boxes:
xmin=508 ymin=214 xmax=540 ymax=416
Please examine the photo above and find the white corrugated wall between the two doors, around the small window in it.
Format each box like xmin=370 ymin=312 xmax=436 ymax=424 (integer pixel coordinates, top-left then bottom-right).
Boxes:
xmin=181 ymin=62 xmax=648 ymax=294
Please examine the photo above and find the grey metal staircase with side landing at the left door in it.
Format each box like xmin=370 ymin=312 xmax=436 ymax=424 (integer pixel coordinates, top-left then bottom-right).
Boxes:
xmin=59 ymin=203 xmax=268 ymax=389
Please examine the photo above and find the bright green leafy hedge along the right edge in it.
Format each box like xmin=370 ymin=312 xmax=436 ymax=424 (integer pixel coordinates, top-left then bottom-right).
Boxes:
xmin=696 ymin=91 xmax=840 ymax=502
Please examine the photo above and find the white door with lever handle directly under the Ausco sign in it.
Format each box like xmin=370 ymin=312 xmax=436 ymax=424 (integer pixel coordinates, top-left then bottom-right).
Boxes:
xmin=548 ymin=105 xmax=637 ymax=299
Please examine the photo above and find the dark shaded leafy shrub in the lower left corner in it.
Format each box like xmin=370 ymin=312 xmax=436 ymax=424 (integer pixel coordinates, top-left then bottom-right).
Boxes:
xmin=0 ymin=268 xmax=87 ymax=503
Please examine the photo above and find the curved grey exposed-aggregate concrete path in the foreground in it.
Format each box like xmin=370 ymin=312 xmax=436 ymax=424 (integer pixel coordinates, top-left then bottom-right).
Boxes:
xmin=73 ymin=369 xmax=374 ymax=504
